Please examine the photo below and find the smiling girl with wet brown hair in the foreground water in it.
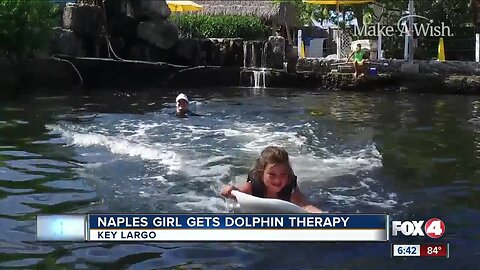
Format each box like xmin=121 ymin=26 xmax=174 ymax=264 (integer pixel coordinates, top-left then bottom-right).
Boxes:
xmin=222 ymin=146 xmax=323 ymax=213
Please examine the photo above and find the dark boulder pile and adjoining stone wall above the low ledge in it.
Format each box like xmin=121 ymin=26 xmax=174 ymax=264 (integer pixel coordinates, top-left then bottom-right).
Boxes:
xmin=50 ymin=0 xmax=286 ymax=69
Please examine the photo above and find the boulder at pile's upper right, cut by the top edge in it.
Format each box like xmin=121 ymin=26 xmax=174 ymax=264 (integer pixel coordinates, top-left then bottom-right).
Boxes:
xmin=132 ymin=0 xmax=171 ymax=20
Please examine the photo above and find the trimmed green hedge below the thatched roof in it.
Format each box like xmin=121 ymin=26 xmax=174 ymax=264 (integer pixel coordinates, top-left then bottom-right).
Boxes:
xmin=169 ymin=13 xmax=271 ymax=39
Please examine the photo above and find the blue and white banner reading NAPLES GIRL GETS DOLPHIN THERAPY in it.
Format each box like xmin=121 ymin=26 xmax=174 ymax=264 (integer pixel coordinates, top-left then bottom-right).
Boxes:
xmin=37 ymin=214 xmax=389 ymax=242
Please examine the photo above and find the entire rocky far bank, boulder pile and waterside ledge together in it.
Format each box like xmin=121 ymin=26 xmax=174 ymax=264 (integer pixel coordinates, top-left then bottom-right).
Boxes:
xmin=0 ymin=0 xmax=480 ymax=98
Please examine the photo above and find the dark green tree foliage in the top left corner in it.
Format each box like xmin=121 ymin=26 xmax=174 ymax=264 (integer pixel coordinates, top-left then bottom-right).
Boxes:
xmin=0 ymin=0 xmax=58 ymax=60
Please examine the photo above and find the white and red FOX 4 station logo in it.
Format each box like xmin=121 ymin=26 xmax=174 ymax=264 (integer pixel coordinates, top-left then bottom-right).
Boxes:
xmin=392 ymin=218 xmax=445 ymax=238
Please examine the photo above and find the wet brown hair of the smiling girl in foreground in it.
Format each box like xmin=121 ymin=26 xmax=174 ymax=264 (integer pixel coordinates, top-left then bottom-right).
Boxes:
xmin=253 ymin=146 xmax=295 ymax=179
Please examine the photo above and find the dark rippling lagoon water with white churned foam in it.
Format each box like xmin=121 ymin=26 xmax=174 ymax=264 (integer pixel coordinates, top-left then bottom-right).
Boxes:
xmin=0 ymin=88 xmax=480 ymax=269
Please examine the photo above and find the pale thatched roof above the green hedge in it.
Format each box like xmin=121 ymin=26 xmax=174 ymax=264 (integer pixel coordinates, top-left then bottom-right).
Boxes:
xmin=195 ymin=0 xmax=296 ymax=26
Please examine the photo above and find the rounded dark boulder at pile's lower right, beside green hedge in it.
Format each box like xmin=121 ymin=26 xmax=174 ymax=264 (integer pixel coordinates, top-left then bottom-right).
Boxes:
xmin=137 ymin=20 xmax=178 ymax=50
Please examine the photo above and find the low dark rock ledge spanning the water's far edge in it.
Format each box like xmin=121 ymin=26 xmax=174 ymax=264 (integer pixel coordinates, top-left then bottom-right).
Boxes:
xmin=0 ymin=56 xmax=480 ymax=95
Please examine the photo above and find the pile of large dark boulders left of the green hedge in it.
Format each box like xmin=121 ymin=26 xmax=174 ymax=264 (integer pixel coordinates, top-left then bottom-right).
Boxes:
xmin=51 ymin=0 xmax=178 ymax=60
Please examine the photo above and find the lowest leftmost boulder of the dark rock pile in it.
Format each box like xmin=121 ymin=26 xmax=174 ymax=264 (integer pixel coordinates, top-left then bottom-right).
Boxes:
xmin=50 ymin=27 xmax=86 ymax=57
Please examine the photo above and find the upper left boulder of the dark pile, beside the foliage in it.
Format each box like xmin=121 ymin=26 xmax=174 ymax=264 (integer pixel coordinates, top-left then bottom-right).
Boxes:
xmin=63 ymin=4 xmax=103 ymax=38
